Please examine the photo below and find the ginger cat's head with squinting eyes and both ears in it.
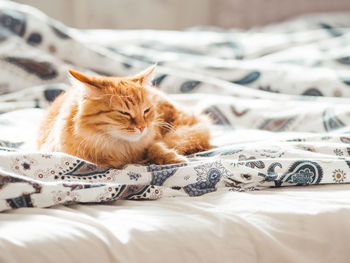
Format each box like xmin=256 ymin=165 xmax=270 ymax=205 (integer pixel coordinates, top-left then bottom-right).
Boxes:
xmin=69 ymin=66 xmax=157 ymax=142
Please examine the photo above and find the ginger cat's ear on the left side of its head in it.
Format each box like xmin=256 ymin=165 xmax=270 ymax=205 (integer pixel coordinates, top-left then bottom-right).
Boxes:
xmin=68 ymin=69 xmax=101 ymax=97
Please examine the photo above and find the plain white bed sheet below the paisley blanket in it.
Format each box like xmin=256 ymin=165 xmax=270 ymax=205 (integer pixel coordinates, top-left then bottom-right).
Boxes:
xmin=0 ymin=185 xmax=350 ymax=263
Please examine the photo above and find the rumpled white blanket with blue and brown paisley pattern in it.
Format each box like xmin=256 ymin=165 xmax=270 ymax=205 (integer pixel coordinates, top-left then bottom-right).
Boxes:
xmin=0 ymin=1 xmax=350 ymax=211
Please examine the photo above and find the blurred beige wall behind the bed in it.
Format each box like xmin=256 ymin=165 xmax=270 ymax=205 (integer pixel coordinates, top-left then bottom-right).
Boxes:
xmin=16 ymin=0 xmax=350 ymax=29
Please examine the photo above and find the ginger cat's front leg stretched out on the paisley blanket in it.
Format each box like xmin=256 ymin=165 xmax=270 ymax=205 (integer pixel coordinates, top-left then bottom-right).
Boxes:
xmin=147 ymin=142 xmax=187 ymax=165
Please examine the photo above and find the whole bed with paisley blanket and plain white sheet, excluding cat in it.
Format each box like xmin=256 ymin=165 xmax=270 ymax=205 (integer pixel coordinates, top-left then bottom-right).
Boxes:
xmin=0 ymin=1 xmax=350 ymax=263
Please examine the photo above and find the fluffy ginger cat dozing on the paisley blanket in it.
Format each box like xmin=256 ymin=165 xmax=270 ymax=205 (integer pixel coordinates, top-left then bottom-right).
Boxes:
xmin=38 ymin=66 xmax=212 ymax=168
